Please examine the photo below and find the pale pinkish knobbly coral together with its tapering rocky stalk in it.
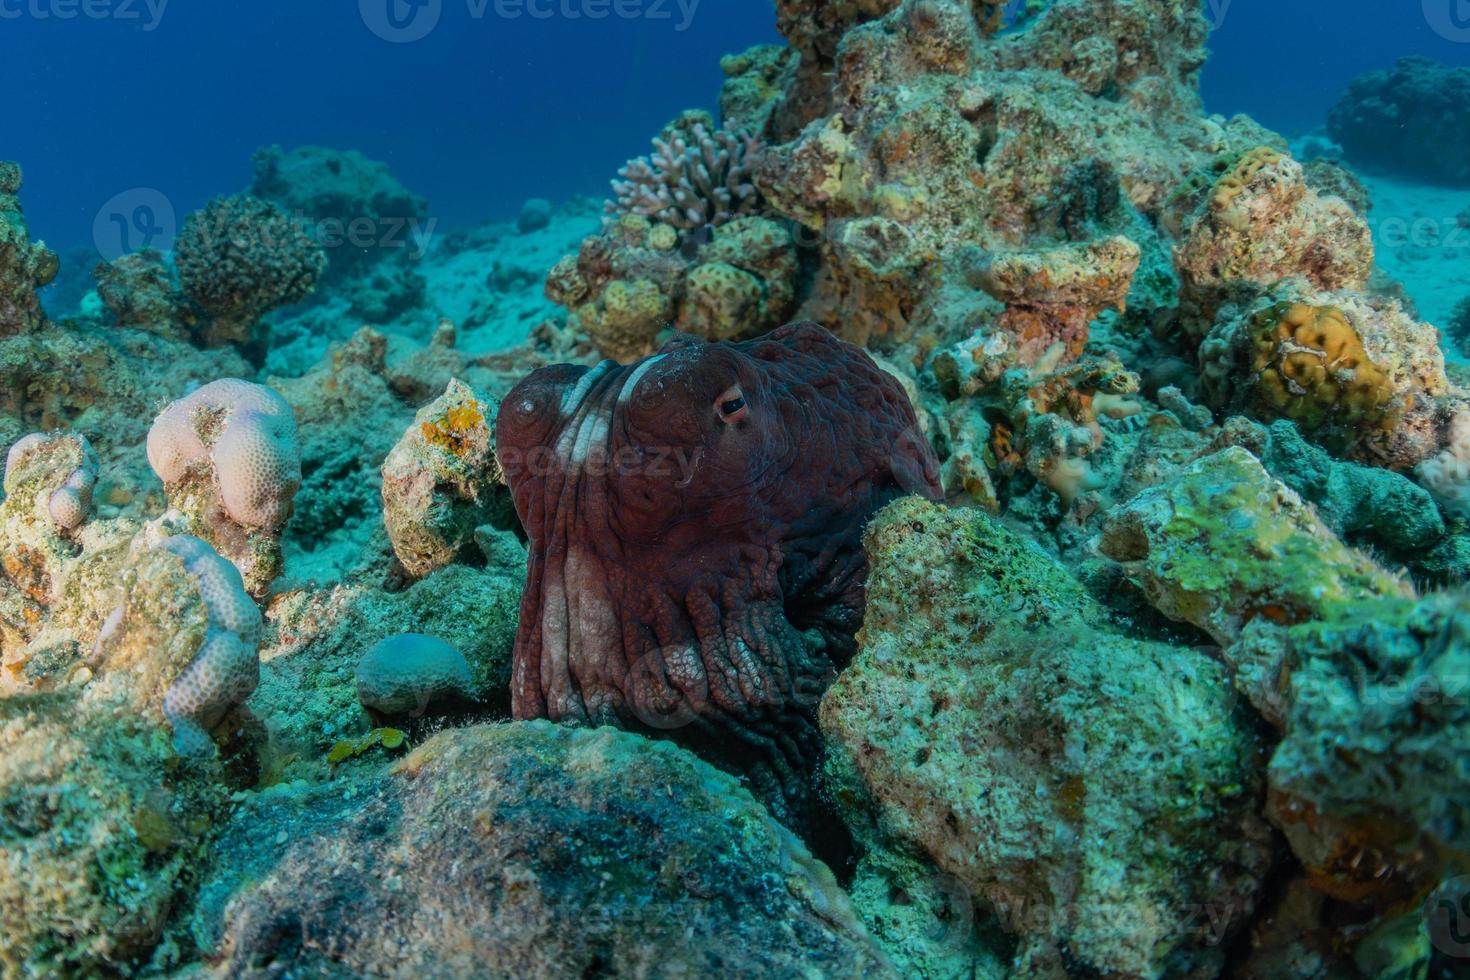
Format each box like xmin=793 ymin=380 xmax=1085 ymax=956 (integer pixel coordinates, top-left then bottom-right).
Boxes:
xmin=148 ymin=379 xmax=301 ymax=597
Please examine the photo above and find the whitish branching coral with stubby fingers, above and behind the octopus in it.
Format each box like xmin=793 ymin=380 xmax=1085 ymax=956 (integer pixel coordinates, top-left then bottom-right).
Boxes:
xmin=606 ymin=119 xmax=764 ymax=231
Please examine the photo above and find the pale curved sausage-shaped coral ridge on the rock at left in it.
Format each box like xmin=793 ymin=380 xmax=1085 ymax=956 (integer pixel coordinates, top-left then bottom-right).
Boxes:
xmin=156 ymin=535 xmax=260 ymax=758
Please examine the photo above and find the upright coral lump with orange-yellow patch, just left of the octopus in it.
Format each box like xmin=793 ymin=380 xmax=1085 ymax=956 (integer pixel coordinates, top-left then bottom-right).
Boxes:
xmin=382 ymin=381 xmax=515 ymax=577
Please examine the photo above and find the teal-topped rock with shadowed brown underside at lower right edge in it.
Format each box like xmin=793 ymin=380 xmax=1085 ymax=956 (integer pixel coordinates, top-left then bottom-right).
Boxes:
xmin=1227 ymin=592 xmax=1470 ymax=909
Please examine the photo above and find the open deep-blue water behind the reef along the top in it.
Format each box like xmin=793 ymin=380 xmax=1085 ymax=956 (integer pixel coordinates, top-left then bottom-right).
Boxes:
xmin=0 ymin=0 xmax=1470 ymax=248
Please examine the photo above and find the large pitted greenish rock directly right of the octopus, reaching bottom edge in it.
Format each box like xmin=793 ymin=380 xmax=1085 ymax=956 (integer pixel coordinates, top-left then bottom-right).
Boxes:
xmin=822 ymin=500 xmax=1270 ymax=976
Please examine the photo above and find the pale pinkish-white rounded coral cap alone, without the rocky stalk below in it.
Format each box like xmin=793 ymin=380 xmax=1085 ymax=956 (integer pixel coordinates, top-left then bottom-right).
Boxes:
xmin=148 ymin=378 xmax=301 ymax=529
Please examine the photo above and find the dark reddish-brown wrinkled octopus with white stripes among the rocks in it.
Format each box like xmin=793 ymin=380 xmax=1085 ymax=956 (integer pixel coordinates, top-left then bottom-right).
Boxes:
xmin=495 ymin=323 xmax=939 ymax=824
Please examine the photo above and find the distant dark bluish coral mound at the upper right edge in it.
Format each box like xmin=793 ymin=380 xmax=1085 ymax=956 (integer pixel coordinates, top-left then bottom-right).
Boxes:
xmin=1327 ymin=57 xmax=1470 ymax=185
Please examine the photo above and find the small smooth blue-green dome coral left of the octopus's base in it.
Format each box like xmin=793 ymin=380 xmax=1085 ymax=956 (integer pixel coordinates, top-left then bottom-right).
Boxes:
xmin=357 ymin=633 xmax=475 ymax=717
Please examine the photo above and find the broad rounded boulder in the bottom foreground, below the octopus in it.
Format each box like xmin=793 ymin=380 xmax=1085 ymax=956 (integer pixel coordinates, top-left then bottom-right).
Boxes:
xmin=193 ymin=721 xmax=895 ymax=980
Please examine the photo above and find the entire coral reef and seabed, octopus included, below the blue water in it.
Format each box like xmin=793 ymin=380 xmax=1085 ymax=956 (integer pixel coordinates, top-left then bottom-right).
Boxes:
xmin=0 ymin=0 xmax=1470 ymax=980
